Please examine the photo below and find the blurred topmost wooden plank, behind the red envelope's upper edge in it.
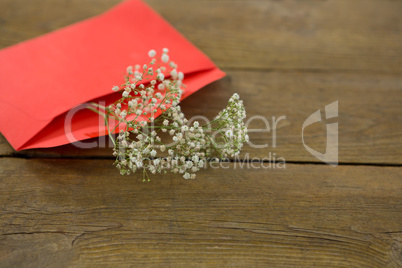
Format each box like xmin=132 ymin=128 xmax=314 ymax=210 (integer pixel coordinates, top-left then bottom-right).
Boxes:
xmin=0 ymin=0 xmax=402 ymax=73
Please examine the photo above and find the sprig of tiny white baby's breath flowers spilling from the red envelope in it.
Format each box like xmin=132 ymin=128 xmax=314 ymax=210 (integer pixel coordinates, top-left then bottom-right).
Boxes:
xmin=94 ymin=48 xmax=248 ymax=180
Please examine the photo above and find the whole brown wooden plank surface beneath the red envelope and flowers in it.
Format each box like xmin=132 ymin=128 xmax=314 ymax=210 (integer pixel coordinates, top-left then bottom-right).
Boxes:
xmin=0 ymin=0 xmax=402 ymax=267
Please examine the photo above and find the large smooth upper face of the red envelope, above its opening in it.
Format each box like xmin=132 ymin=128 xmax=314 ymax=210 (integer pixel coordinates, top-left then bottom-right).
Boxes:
xmin=0 ymin=0 xmax=215 ymax=120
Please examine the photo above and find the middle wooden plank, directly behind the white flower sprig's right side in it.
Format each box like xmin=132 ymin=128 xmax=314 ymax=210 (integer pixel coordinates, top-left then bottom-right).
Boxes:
xmin=0 ymin=71 xmax=402 ymax=164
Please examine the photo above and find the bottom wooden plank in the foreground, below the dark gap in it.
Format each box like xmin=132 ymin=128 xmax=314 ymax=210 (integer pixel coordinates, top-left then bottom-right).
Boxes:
xmin=0 ymin=157 xmax=402 ymax=267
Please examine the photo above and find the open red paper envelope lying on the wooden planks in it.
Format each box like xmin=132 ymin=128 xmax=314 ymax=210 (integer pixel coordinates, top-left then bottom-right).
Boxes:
xmin=0 ymin=0 xmax=225 ymax=150
